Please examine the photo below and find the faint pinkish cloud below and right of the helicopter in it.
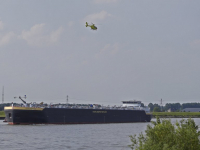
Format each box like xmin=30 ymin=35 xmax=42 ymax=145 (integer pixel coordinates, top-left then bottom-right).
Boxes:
xmin=95 ymin=43 xmax=119 ymax=58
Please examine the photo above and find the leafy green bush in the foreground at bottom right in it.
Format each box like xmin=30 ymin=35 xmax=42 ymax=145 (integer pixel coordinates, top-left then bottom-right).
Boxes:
xmin=129 ymin=118 xmax=200 ymax=150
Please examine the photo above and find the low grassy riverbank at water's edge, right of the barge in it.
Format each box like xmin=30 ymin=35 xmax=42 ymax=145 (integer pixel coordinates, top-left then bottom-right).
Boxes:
xmin=152 ymin=112 xmax=200 ymax=118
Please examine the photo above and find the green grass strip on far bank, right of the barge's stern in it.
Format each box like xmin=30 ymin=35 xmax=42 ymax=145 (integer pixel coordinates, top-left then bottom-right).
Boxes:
xmin=152 ymin=112 xmax=200 ymax=117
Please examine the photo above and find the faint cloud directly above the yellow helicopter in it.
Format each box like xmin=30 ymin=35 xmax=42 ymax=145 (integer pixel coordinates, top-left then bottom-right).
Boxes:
xmin=84 ymin=10 xmax=112 ymax=22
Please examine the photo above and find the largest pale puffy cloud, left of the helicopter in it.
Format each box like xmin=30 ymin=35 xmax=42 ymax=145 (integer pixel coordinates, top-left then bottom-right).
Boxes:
xmin=19 ymin=23 xmax=64 ymax=46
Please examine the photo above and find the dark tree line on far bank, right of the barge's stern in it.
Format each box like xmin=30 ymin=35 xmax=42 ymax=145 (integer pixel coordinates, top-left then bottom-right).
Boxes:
xmin=148 ymin=103 xmax=200 ymax=112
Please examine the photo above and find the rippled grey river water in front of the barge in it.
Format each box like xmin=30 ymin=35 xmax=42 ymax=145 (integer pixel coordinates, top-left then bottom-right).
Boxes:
xmin=0 ymin=118 xmax=200 ymax=150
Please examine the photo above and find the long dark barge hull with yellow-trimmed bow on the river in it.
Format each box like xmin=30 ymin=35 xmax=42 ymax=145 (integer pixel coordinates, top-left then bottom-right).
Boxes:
xmin=4 ymin=101 xmax=151 ymax=124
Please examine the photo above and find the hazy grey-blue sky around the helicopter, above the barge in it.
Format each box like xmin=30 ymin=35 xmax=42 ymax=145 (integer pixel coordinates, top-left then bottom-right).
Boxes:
xmin=0 ymin=0 xmax=200 ymax=105
